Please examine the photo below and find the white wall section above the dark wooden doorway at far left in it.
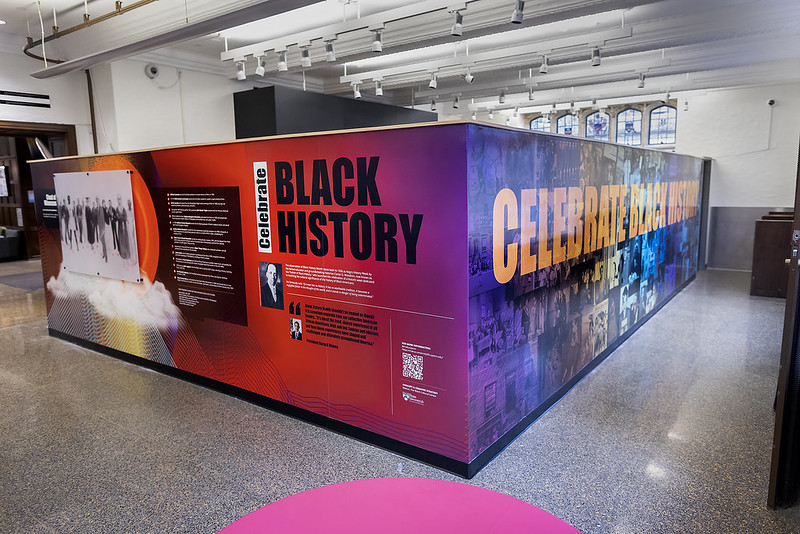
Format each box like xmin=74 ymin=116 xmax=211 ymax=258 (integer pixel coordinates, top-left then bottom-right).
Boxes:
xmin=0 ymin=40 xmax=94 ymax=154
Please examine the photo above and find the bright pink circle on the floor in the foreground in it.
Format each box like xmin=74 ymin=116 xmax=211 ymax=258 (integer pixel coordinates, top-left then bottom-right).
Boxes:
xmin=220 ymin=478 xmax=579 ymax=534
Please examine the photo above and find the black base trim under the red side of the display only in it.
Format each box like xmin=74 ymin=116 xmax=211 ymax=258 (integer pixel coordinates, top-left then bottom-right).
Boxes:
xmin=48 ymin=328 xmax=477 ymax=478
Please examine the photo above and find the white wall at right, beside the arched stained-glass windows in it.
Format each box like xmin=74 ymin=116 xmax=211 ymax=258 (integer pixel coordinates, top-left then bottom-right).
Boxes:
xmin=675 ymin=84 xmax=800 ymax=207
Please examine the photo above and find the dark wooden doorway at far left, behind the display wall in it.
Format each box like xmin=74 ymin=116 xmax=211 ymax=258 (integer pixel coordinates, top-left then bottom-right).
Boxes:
xmin=0 ymin=121 xmax=78 ymax=259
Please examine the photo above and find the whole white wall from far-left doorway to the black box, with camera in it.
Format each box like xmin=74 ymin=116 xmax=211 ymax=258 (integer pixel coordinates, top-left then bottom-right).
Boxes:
xmin=0 ymin=41 xmax=242 ymax=155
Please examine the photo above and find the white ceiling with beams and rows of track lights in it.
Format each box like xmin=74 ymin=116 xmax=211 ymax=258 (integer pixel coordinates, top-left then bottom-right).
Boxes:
xmin=0 ymin=0 xmax=800 ymax=114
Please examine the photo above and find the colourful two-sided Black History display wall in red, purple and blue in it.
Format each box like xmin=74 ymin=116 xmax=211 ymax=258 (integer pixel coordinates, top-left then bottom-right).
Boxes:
xmin=32 ymin=122 xmax=701 ymax=477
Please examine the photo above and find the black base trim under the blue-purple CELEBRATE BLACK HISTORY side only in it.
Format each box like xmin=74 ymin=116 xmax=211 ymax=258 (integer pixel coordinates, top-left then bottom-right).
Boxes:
xmin=467 ymin=276 xmax=696 ymax=478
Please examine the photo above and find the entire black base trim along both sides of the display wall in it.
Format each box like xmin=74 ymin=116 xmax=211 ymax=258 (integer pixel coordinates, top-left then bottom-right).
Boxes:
xmin=48 ymin=276 xmax=695 ymax=479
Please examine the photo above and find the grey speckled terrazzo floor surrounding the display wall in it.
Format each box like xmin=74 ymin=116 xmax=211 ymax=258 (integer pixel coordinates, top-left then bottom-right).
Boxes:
xmin=0 ymin=262 xmax=800 ymax=533
